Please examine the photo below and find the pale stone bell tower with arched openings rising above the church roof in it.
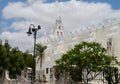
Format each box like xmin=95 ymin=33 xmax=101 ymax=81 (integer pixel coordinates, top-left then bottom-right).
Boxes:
xmin=53 ymin=17 xmax=64 ymax=37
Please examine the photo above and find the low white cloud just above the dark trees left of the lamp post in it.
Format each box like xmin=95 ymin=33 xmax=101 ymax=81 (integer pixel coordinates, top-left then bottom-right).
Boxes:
xmin=0 ymin=32 xmax=33 ymax=51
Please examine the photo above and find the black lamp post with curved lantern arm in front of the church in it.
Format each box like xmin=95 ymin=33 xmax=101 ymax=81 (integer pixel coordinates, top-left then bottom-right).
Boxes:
xmin=27 ymin=24 xmax=41 ymax=84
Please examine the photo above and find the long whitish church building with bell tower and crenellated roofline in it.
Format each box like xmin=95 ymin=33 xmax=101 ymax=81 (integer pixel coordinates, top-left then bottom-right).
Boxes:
xmin=36 ymin=17 xmax=120 ymax=84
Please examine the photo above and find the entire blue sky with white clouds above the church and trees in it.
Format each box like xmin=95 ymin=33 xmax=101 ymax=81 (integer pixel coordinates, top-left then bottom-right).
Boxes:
xmin=0 ymin=0 xmax=120 ymax=51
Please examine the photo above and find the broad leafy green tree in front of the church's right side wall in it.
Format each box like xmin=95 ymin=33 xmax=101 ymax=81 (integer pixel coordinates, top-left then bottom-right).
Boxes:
xmin=56 ymin=42 xmax=115 ymax=83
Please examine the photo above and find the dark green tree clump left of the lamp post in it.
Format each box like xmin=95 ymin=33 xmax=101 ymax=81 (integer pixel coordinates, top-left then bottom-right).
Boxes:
xmin=0 ymin=40 xmax=33 ymax=78
